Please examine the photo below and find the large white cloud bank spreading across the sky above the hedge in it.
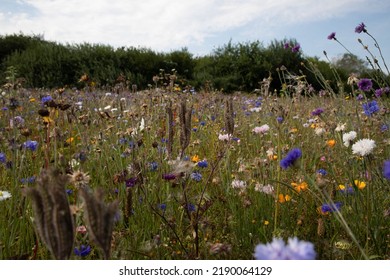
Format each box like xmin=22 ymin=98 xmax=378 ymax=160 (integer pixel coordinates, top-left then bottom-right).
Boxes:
xmin=0 ymin=0 xmax=389 ymax=51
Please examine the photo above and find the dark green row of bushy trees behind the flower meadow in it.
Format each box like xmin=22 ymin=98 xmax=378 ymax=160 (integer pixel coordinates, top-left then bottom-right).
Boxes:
xmin=0 ymin=34 xmax=367 ymax=93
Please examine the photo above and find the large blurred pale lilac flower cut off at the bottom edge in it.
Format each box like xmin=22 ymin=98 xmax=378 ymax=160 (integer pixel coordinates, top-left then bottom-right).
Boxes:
xmin=253 ymin=237 xmax=316 ymax=260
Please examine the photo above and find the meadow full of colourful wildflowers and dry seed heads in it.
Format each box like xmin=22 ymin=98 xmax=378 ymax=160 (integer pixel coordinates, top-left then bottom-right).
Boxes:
xmin=0 ymin=23 xmax=390 ymax=260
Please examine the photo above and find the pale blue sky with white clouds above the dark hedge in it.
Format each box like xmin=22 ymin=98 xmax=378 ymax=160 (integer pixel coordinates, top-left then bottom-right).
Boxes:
xmin=0 ymin=0 xmax=390 ymax=63
